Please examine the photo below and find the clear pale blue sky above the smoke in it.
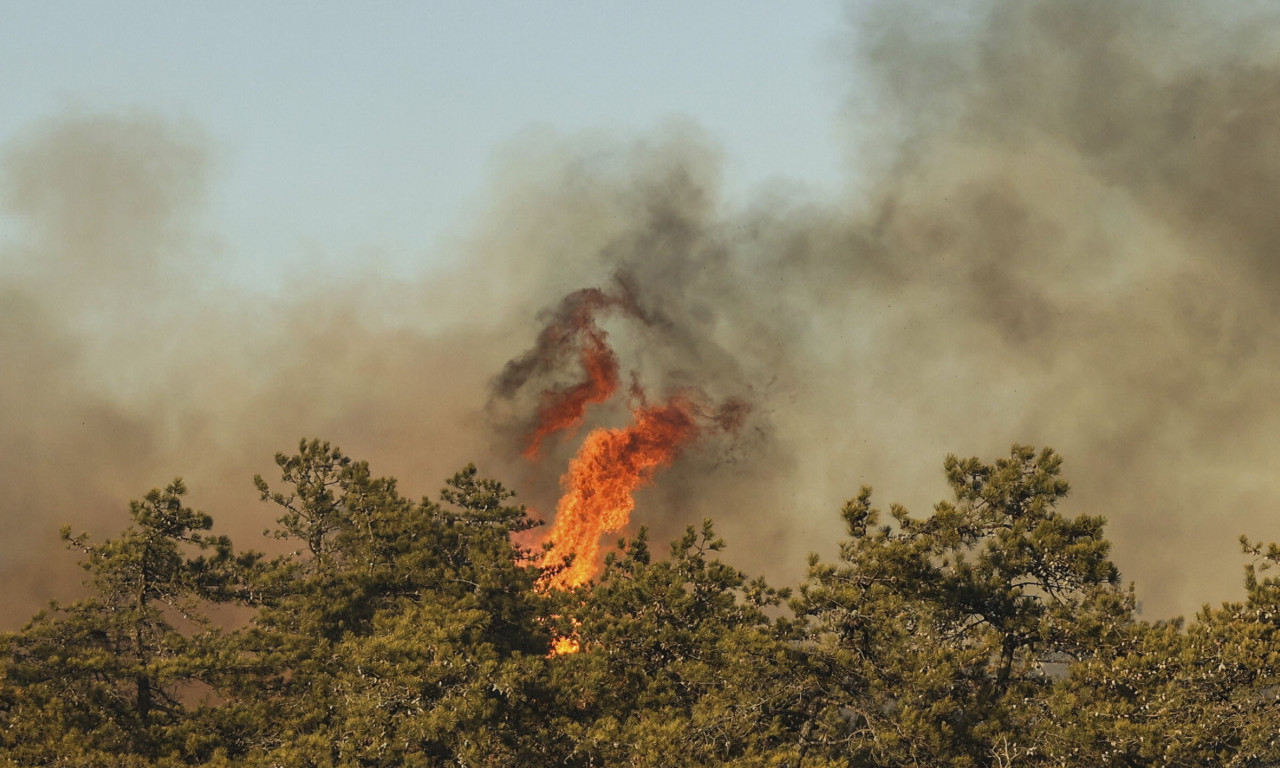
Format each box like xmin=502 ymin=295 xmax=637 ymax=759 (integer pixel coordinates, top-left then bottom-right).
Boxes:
xmin=0 ymin=0 xmax=844 ymax=279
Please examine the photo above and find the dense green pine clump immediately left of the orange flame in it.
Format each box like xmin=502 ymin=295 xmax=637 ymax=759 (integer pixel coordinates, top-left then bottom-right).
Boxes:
xmin=228 ymin=440 xmax=550 ymax=765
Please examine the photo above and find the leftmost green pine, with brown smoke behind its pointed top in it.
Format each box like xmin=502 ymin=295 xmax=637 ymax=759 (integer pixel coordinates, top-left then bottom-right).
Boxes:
xmin=0 ymin=480 xmax=247 ymax=763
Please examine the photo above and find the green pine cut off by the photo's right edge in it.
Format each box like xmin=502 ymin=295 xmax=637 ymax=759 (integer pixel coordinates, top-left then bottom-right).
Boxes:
xmin=1042 ymin=539 xmax=1280 ymax=767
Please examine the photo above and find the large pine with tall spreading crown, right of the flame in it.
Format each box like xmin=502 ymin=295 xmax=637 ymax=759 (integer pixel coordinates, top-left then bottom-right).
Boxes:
xmin=794 ymin=445 xmax=1132 ymax=765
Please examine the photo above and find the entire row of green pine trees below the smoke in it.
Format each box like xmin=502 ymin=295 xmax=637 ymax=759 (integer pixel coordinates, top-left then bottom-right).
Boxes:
xmin=0 ymin=440 xmax=1280 ymax=767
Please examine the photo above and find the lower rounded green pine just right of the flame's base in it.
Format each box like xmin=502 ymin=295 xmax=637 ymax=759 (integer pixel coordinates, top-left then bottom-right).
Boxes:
xmin=554 ymin=521 xmax=810 ymax=767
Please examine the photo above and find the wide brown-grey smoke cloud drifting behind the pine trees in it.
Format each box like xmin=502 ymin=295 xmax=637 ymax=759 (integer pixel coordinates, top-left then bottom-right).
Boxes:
xmin=0 ymin=0 xmax=1280 ymax=626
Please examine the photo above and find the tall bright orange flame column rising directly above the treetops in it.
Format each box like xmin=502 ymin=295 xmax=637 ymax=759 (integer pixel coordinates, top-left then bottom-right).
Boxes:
xmin=543 ymin=394 xmax=699 ymax=589
